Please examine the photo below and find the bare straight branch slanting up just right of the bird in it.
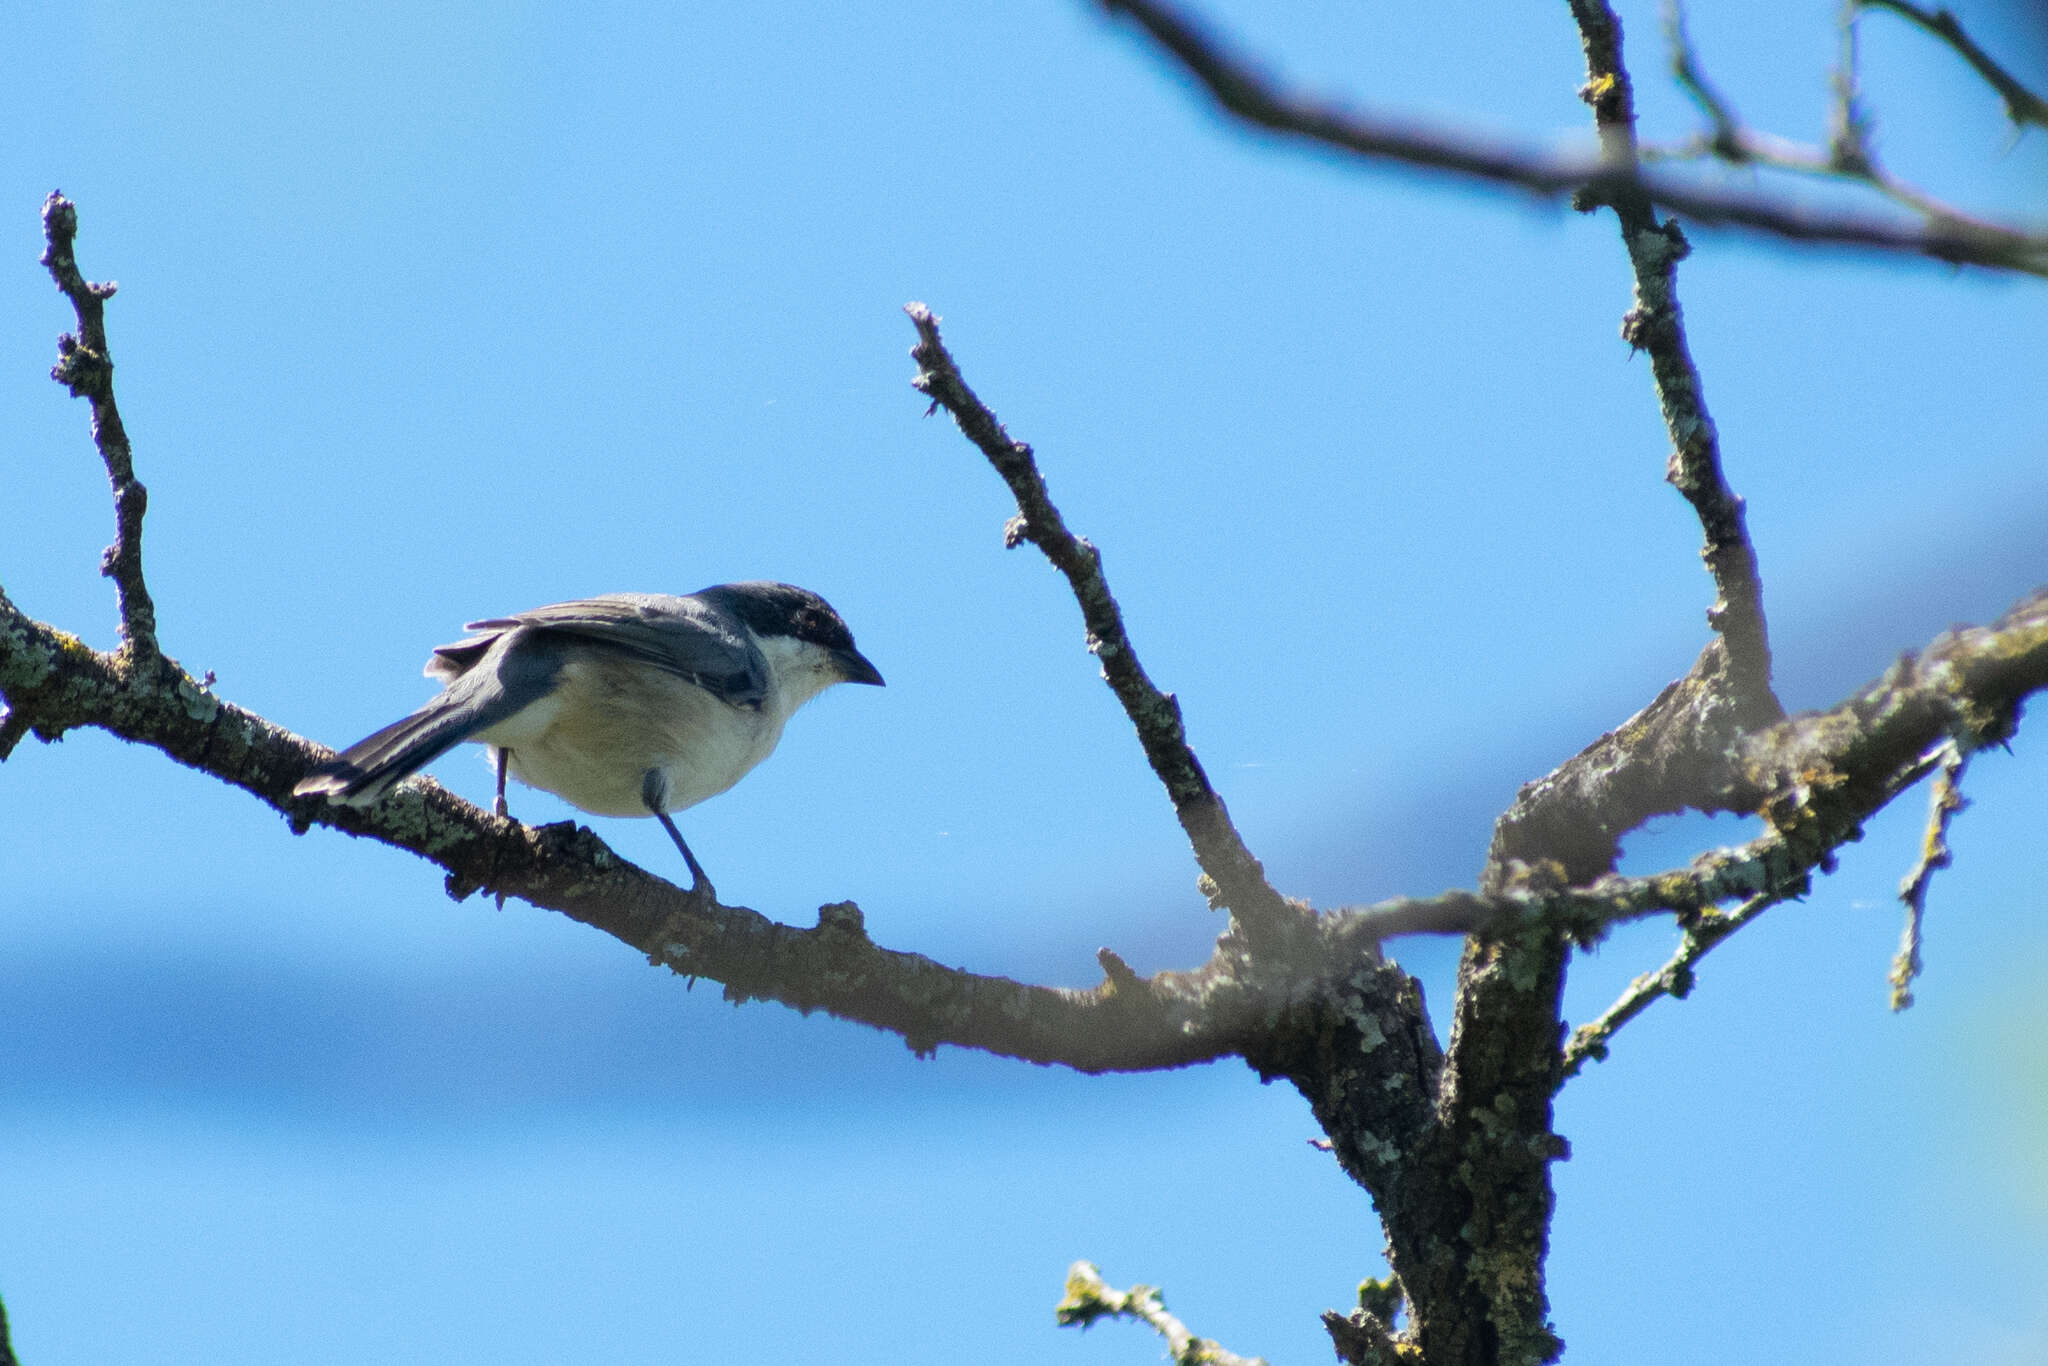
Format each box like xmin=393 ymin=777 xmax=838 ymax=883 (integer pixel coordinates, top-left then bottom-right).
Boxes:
xmin=903 ymin=303 xmax=1303 ymax=936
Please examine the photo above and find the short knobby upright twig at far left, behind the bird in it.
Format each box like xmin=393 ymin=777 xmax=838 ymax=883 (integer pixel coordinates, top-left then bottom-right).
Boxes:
xmin=43 ymin=193 xmax=160 ymax=661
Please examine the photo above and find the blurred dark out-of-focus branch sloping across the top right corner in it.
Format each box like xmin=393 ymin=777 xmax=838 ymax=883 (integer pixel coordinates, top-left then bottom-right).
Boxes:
xmin=1100 ymin=0 xmax=2048 ymax=276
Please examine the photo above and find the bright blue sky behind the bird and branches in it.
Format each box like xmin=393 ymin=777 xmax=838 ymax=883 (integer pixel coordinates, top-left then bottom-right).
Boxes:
xmin=0 ymin=0 xmax=2048 ymax=1366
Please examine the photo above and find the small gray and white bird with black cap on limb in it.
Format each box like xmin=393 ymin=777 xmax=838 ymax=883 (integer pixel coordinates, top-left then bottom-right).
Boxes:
xmin=293 ymin=584 xmax=883 ymax=897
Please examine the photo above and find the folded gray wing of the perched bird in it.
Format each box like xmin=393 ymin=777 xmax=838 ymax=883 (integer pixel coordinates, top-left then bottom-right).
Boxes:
xmin=460 ymin=594 xmax=768 ymax=707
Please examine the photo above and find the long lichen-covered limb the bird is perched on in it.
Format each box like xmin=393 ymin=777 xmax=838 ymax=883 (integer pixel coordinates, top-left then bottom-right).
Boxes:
xmin=0 ymin=573 xmax=1329 ymax=1071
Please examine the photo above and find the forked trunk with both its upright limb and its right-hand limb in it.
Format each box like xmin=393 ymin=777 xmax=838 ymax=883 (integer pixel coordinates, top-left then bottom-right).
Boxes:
xmin=1261 ymin=0 xmax=2048 ymax=1362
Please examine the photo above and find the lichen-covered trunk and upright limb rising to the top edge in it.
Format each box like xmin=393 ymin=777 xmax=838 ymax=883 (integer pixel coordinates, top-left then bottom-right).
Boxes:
xmin=1296 ymin=0 xmax=1782 ymax=1366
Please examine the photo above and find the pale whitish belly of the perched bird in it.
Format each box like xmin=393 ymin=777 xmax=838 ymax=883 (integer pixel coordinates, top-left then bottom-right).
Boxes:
xmin=475 ymin=651 xmax=784 ymax=815
